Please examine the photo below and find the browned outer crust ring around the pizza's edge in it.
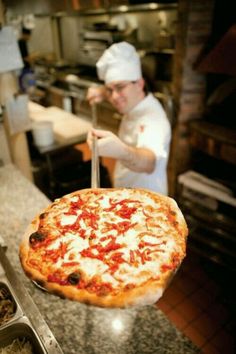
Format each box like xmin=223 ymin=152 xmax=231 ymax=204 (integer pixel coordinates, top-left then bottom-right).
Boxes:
xmin=19 ymin=188 xmax=188 ymax=308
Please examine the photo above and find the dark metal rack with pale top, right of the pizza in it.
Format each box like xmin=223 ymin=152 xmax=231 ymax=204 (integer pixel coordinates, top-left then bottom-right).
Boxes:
xmin=178 ymin=171 xmax=236 ymax=272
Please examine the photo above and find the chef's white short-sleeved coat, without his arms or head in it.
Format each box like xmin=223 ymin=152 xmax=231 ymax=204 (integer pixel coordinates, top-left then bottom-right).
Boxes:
xmin=114 ymin=93 xmax=171 ymax=195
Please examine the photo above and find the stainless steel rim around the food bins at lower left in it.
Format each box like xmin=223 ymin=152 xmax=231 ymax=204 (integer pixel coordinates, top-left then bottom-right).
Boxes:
xmin=0 ymin=245 xmax=63 ymax=354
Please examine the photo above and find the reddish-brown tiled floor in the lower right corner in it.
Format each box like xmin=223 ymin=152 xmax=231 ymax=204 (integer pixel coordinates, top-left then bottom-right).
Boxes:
xmin=157 ymin=251 xmax=236 ymax=354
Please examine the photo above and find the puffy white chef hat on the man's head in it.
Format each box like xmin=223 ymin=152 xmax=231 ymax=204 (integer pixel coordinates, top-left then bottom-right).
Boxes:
xmin=96 ymin=42 xmax=142 ymax=84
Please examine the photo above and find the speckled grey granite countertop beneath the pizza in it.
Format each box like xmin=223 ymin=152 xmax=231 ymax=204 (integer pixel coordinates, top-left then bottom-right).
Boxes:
xmin=0 ymin=165 xmax=199 ymax=354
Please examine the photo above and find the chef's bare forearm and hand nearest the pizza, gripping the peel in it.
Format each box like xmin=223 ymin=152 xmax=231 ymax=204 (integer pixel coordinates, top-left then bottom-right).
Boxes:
xmin=87 ymin=129 xmax=156 ymax=173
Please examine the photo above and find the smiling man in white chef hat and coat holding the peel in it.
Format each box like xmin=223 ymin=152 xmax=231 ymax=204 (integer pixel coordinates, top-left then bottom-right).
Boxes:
xmin=87 ymin=42 xmax=171 ymax=195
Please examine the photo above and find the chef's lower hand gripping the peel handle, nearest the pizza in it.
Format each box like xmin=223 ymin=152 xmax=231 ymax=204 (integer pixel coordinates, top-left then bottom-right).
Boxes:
xmin=87 ymin=129 xmax=128 ymax=160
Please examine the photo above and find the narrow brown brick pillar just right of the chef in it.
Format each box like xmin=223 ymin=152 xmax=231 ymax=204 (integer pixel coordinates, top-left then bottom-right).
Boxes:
xmin=169 ymin=0 xmax=214 ymax=196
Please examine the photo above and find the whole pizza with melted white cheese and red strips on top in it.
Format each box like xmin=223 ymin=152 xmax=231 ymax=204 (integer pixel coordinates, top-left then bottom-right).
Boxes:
xmin=19 ymin=188 xmax=188 ymax=308
